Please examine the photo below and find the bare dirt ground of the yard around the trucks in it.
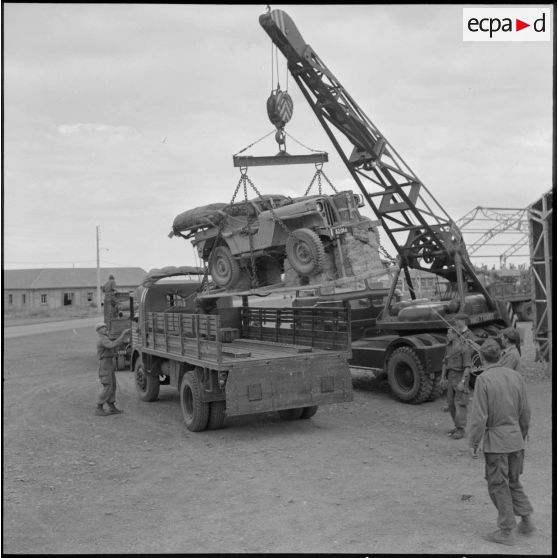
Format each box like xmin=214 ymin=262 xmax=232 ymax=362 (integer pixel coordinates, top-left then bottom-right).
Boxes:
xmin=2 ymin=324 xmax=554 ymax=555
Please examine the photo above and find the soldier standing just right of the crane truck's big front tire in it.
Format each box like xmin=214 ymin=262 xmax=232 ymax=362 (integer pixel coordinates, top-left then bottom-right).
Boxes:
xmin=441 ymin=314 xmax=473 ymax=440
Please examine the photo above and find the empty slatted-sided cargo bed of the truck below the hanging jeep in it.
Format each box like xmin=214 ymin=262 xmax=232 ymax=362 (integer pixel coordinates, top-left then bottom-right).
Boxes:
xmin=140 ymin=308 xmax=350 ymax=370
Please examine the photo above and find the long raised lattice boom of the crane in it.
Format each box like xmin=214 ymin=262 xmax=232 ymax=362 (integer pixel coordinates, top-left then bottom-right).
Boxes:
xmin=259 ymin=10 xmax=494 ymax=308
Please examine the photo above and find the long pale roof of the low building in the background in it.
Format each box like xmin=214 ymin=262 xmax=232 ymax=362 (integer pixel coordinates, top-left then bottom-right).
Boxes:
xmin=3 ymin=267 xmax=146 ymax=290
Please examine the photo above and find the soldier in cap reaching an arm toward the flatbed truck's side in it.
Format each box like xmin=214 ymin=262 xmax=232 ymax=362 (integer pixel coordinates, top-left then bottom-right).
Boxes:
xmin=95 ymin=323 xmax=131 ymax=417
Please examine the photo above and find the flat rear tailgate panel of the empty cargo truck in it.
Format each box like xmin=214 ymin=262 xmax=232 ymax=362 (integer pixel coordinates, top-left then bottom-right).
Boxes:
xmin=225 ymin=352 xmax=353 ymax=416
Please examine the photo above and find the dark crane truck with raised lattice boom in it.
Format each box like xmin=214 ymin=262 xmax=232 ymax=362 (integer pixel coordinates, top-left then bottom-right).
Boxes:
xmin=259 ymin=10 xmax=513 ymax=403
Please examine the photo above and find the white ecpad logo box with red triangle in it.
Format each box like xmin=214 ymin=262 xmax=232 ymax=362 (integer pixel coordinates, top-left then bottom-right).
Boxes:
xmin=463 ymin=8 xmax=552 ymax=41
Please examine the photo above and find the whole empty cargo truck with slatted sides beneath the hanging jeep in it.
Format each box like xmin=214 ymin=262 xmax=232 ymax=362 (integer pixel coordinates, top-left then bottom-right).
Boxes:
xmin=132 ymin=278 xmax=352 ymax=431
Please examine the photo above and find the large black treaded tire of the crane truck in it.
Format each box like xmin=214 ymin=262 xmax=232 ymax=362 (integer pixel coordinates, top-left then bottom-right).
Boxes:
xmin=387 ymin=347 xmax=433 ymax=404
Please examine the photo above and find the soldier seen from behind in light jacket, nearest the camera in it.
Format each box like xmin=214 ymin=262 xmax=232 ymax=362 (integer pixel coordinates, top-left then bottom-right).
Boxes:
xmin=469 ymin=339 xmax=535 ymax=546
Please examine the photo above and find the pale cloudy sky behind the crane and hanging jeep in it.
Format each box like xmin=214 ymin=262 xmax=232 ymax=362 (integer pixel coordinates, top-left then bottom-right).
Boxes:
xmin=2 ymin=3 xmax=553 ymax=270
